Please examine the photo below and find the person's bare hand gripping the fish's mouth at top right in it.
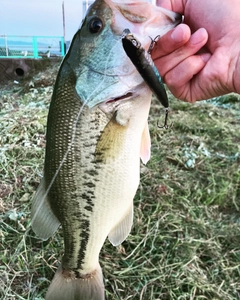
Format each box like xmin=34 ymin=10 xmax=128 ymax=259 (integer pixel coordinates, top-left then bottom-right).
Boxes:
xmin=152 ymin=0 xmax=240 ymax=102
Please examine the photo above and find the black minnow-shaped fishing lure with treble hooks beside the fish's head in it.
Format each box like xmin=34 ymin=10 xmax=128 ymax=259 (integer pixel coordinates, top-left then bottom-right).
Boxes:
xmin=122 ymin=29 xmax=169 ymax=129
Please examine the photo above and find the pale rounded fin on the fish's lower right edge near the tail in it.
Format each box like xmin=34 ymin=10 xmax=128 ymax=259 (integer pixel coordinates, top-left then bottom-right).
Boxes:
xmin=108 ymin=205 xmax=133 ymax=246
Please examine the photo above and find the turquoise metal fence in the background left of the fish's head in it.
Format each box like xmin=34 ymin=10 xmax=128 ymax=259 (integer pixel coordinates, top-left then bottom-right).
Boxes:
xmin=0 ymin=35 xmax=66 ymax=58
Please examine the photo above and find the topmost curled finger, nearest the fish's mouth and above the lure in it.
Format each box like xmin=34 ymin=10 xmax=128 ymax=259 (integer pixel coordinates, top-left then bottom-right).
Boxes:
xmin=151 ymin=24 xmax=191 ymax=60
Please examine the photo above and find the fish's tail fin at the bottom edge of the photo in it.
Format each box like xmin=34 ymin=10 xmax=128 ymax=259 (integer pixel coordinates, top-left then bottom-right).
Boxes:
xmin=45 ymin=265 xmax=105 ymax=300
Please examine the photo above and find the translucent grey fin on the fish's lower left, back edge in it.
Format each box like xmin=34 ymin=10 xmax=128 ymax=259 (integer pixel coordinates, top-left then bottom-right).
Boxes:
xmin=31 ymin=178 xmax=60 ymax=240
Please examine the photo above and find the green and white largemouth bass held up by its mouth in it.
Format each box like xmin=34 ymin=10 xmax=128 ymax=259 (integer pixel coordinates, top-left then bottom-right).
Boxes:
xmin=31 ymin=0 xmax=179 ymax=300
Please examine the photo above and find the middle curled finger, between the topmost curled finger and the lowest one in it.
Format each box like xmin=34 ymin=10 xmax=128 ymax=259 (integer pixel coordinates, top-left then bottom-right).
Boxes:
xmin=155 ymin=28 xmax=208 ymax=77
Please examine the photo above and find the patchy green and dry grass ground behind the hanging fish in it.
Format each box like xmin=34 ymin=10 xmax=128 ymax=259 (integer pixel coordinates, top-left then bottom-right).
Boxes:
xmin=0 ymin=62 xmax=240 ymax=300
